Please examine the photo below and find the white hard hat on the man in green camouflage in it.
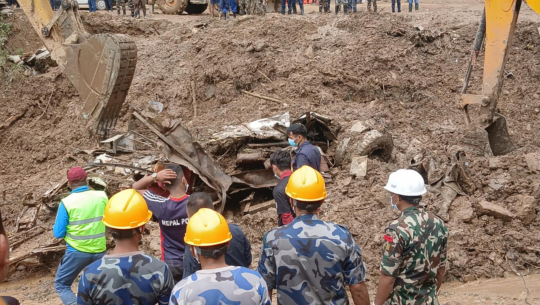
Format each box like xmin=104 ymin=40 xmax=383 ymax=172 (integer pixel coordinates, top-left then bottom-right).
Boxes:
xmin=384 ymin=169 xmax=427 ymax=196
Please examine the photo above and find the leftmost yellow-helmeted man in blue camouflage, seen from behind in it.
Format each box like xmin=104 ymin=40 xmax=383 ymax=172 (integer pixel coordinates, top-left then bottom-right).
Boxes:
xmin=77 ymin=189 xmax=174 ymax=305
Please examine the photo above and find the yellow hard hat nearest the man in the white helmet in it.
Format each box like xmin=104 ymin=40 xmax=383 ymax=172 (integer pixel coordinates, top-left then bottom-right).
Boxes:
xmin=285 ymin=165 xmax=326 ymax=202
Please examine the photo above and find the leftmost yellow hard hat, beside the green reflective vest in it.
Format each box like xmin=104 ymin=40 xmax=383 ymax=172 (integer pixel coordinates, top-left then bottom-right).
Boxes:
xmin=103 ymin=189 xmax=152 ymax=230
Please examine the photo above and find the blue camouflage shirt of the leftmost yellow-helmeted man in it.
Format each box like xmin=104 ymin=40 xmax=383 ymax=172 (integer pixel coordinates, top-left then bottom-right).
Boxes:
xmin=77 ymin=251 xmax=174 ymax=305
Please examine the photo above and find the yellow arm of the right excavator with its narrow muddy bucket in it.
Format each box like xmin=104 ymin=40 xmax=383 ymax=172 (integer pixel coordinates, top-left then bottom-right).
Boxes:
xmin=461 ymin=0 xmax=540 ymax=155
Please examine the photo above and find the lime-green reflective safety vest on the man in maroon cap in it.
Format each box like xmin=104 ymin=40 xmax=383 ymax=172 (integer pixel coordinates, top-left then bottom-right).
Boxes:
xmin=62 ymin=190 xmax=108 ymax=253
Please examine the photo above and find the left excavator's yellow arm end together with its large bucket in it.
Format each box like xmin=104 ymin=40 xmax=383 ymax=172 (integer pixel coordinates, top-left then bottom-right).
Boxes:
xmin=18 ymin=0 xmax=137 ymax=137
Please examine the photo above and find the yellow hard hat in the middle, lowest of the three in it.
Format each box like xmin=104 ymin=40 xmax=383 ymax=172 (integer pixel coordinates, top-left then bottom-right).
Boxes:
xmin=184 ymin=208 xmax=232 ymax=247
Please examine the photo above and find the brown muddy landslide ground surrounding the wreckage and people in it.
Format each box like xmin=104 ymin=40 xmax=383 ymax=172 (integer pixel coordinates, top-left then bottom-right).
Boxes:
xmin=0 ymin=0 xmax=540 ymax=304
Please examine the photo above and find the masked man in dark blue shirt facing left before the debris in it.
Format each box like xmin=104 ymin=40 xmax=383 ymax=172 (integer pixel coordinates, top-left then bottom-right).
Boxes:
xmin=287 ymin=122 xmax=320 ymax=171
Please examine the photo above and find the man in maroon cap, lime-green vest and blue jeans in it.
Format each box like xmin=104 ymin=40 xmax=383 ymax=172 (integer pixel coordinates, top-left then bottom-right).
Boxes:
xmin=53 ymin=167 xmax=108 ymax=305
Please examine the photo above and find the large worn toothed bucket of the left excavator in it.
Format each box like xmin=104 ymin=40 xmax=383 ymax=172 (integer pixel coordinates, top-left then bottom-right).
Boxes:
xmin=64 ymin=34 xmax=137 ymax=137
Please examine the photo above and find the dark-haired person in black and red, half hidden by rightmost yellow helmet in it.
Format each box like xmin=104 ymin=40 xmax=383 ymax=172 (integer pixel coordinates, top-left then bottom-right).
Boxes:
xmin=270 ymin=150 xmax=296 ymax=227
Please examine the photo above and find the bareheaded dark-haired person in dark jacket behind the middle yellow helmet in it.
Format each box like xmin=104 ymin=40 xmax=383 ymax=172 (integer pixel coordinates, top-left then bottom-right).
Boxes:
xmin=179 ymin=193 xmax=252 ymax=278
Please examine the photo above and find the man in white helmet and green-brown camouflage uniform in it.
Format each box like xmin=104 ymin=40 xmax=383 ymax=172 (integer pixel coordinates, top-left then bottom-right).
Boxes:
xmin=375 ymin=169 xmax=448 ymax=305
